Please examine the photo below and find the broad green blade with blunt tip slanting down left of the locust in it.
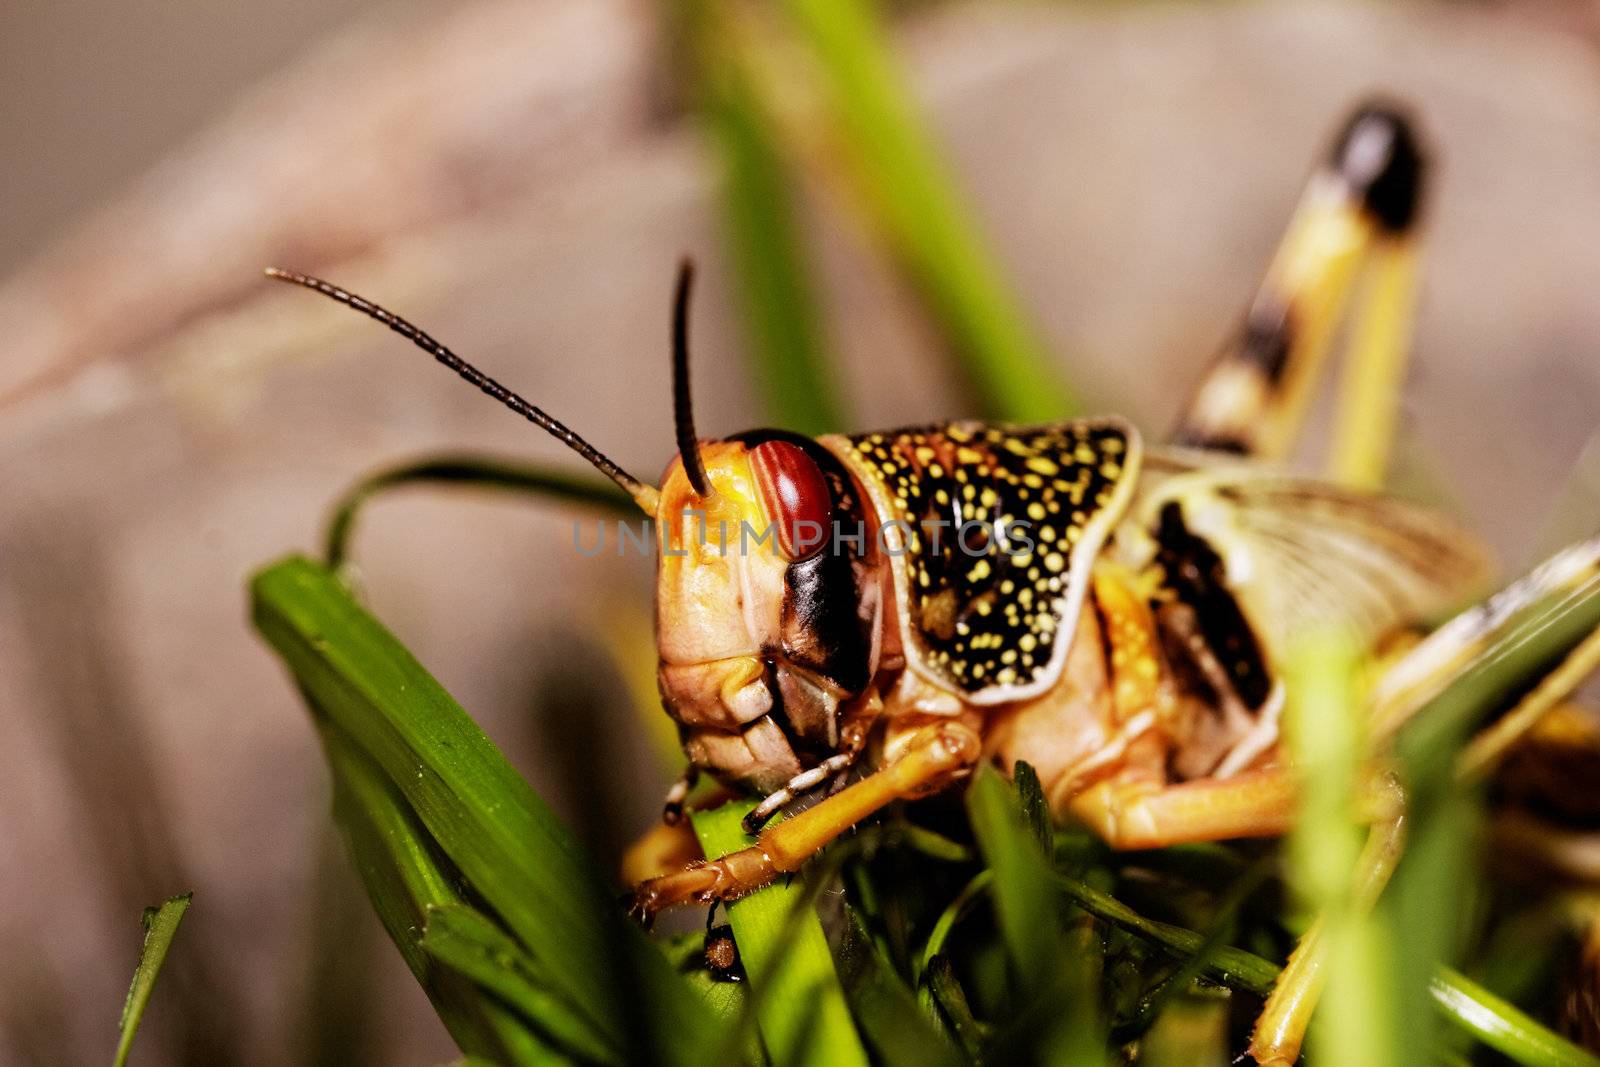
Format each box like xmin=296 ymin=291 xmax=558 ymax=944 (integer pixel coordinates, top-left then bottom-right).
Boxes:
xmin=253 ymin=558 xmax=709 ymax=1062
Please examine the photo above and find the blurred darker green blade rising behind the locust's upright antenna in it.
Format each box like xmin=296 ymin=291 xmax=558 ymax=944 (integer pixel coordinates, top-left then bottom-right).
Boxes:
xmin=683 ymin=0 xmax=850 ymax=434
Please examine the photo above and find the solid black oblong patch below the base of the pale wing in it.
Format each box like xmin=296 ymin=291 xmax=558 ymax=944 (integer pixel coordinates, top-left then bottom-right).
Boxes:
xmin=1155 ymin=501 xmax=1272 ymax=710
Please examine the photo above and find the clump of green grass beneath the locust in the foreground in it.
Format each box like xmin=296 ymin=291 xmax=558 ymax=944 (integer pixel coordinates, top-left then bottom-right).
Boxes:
xmin=253 ymin=547 xmax=1600 ymax=1064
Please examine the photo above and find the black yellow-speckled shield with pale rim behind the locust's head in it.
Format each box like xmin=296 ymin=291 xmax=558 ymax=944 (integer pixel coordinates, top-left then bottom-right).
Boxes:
xmin=848 ymin=422 xmax=1136 ymax=693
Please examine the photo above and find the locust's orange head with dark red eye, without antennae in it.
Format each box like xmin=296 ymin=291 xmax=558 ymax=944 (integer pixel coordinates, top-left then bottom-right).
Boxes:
xmin=656 ymin=430 xmax=882 ymax=793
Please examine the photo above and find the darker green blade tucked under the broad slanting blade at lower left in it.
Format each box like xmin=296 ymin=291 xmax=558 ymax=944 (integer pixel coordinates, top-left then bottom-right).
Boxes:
xmin=318 ymin=720 xmax=555 ymax=1064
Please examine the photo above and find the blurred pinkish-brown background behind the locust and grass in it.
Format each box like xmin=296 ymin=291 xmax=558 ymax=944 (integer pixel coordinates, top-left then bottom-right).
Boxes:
xmin=0 ymin=0 xmax=1600 ymax=1064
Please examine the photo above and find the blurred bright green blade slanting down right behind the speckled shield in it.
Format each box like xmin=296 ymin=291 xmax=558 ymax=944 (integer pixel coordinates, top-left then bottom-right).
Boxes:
xmin=782 ymin=0 xmax=1080 ymax=421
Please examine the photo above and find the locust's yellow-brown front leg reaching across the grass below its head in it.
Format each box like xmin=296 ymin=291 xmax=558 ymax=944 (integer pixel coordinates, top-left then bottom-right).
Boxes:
xmin=634 ymin=721 xmax=982 ymax=921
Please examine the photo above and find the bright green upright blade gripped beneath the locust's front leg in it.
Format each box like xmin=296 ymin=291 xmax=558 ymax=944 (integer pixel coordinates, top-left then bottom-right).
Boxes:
xmin=691 ymin=801 xmax=869 ymax=1067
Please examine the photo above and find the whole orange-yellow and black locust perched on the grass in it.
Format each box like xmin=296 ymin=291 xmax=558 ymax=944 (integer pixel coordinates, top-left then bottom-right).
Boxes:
xmin=269 ymin=97 xmax=1597 ymax=1064
